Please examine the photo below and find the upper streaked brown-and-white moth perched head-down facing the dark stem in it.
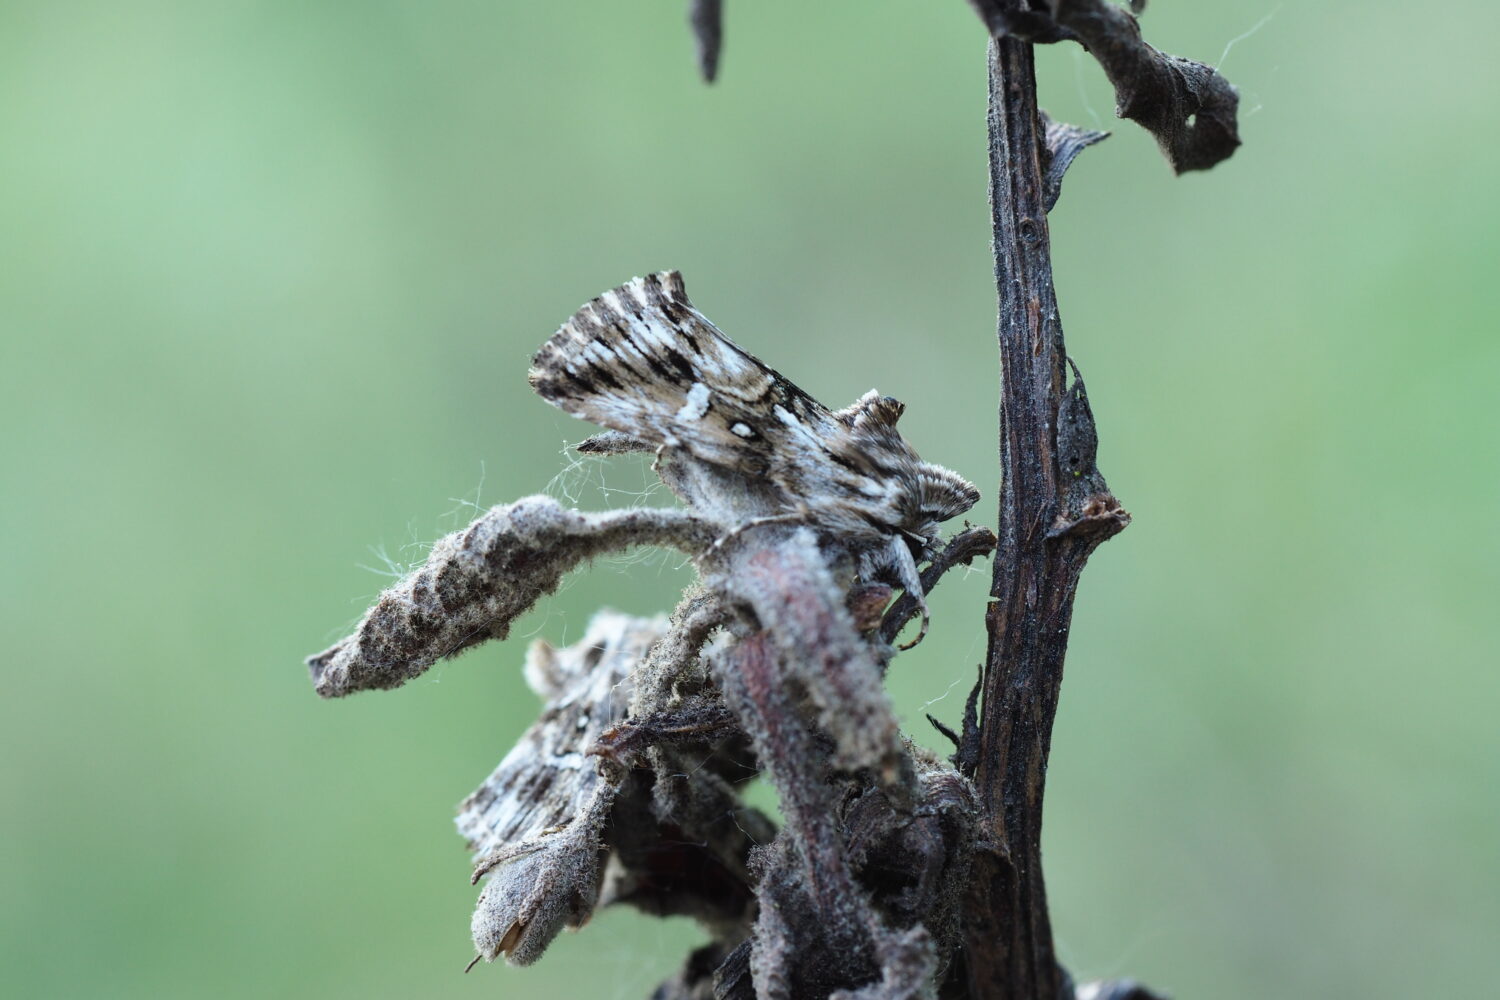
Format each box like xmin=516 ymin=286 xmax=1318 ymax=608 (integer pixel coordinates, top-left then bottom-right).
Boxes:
xmin=531 ymin=271 xmax=980 ymax=631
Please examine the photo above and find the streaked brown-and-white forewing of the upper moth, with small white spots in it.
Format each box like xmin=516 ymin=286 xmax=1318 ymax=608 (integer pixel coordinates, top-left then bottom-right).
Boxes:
xmin=531 ymin=271 xmax=834 ymax=474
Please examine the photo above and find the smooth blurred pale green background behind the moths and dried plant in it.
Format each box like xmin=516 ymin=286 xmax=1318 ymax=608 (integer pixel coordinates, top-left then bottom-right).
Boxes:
xmin=0 ymin=0 xmax=1500 ymax=1000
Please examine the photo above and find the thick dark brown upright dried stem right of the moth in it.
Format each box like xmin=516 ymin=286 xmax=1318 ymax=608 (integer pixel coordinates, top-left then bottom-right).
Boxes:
xmin=965 ymin=37 xmax=1130 ymax=1000
